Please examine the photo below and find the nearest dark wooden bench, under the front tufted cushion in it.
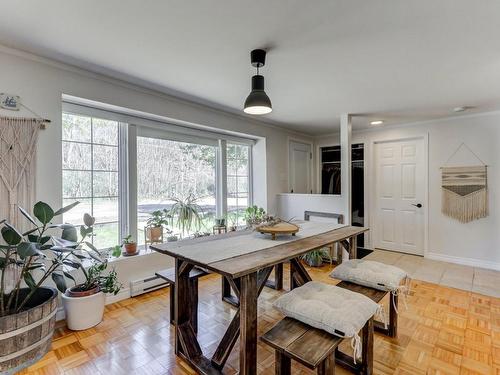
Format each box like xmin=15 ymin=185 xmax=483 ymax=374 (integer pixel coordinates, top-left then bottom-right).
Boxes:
xmin=260 ymin=317 xmax=373 ymax=375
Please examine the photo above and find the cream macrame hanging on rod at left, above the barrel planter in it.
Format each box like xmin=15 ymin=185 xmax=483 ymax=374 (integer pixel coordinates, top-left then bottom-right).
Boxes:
xmin=0 ymin=116 xmax=44 ymax=229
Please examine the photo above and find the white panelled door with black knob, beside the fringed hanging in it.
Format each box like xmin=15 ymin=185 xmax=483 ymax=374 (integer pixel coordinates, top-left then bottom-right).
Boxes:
xmin=373 ymin=139 xmax=427 ymax=255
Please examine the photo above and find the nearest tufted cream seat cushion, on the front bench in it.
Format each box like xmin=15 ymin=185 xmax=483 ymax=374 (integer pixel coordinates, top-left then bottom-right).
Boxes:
xmin=274 ymin=281 xmax=379 ymax=337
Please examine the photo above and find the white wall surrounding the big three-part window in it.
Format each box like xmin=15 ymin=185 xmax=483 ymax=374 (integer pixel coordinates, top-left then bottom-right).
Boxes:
xmin=0 ymin=46 xmax=312 ymax=306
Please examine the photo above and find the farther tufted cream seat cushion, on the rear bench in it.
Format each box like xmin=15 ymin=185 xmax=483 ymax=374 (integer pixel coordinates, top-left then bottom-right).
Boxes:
xmin=330 ymin=259 xmax=408 ymax=292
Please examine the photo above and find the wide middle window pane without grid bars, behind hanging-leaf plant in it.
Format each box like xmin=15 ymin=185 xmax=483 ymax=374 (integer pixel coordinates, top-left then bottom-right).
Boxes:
xmin=137 ymin=137 xmax=217 ymax=243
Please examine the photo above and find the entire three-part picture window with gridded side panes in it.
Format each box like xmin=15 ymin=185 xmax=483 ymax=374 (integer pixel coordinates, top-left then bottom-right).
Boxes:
xmin=62 ymin=101 xmax=252 ymax=249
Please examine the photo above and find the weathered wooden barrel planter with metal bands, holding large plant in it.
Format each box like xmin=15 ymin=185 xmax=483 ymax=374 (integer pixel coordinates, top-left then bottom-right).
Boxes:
xmin=0 ymin=287 xmax=57 ymax=375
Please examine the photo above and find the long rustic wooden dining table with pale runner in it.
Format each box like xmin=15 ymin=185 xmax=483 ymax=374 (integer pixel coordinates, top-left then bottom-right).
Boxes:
xmin=151 ymin=222 xmax=368 ymax=375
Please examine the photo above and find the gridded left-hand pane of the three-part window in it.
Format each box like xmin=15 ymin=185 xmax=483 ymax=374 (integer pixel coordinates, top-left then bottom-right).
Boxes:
xmin=62 ymin=113 xmax=120 ymax=248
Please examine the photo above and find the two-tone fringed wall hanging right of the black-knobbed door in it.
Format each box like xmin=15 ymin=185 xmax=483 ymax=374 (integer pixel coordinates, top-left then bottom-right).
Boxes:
xmin=441 ymin=142 xmax=488 ymax=223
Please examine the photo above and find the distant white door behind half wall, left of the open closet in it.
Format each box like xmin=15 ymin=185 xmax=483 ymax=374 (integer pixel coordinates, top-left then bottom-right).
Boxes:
xmin=288 ymin=141 xmax=312 ymax=193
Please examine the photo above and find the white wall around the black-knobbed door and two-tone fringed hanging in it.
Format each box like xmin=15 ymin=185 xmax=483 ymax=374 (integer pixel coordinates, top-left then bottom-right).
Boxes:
xmin=316 ymin=112 xmax=500 ymax=269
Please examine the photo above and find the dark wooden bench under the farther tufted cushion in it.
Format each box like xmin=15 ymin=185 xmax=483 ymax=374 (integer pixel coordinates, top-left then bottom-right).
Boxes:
xmin=337 ymin=281 xmax=398 ymax=337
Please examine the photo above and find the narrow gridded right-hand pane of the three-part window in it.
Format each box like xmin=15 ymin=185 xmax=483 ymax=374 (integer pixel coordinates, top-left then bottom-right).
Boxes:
xmin=227 ymin=143 xmax=250 ymax=225
